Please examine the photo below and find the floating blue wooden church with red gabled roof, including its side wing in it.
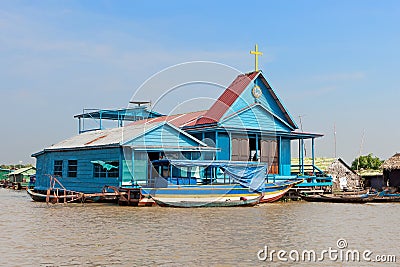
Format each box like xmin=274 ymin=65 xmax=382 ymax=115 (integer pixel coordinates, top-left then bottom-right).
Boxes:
xmin=32 ymin=48 xmax=332 ymax=193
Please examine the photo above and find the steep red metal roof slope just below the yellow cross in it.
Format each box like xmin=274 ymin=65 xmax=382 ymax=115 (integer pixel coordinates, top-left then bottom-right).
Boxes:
xmin=196 ymin=71 xmax=259 ymax=125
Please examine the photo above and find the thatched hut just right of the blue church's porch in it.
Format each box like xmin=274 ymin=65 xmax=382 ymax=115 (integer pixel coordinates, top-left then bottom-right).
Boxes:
xmin=292 ymin=158 xmax=362 ymax=190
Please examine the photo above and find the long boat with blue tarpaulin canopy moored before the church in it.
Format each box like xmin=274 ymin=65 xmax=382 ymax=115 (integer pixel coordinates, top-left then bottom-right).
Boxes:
xmin=139 ymin=160 xmax=268 ymax=207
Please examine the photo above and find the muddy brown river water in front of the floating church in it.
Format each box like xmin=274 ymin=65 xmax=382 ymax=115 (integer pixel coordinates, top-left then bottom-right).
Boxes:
xmin=0 ymin=189 xmax=400 ymax=266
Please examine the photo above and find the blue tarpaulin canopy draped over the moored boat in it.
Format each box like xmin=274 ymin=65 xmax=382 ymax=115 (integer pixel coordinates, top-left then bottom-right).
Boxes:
xmin=153 ymin=160 xmax=267 ymax=191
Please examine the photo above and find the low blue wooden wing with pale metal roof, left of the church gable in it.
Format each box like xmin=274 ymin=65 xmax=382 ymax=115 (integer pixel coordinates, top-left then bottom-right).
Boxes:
xmin=33 ymin=122 xmax=216 ymax=193
